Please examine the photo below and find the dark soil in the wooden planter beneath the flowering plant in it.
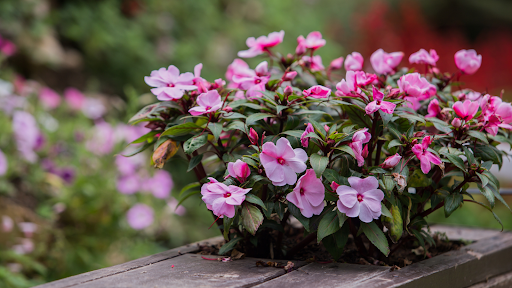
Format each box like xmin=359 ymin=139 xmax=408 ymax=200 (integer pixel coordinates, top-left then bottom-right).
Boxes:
xmin=198 ymin=226 xmax=467 ymax=270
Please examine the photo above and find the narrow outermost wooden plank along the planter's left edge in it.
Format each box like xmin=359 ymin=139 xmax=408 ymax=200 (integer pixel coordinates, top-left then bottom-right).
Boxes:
xmin=36 ymin=236 xmax=224 ymax=288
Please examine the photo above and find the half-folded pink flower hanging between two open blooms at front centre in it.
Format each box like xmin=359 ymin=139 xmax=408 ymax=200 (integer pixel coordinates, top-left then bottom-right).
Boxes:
xmin=286 ymin=169 xmax=325 ymax=218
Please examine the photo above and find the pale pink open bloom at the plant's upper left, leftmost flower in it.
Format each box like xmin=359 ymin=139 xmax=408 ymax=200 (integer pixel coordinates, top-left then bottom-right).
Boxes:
xmin=144 ymin=65 xmax=197 ymax=101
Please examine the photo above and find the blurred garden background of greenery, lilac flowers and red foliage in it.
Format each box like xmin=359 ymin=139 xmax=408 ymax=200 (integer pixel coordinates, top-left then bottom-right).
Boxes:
xmin=0 ymin=0 xmax=512 ymax=287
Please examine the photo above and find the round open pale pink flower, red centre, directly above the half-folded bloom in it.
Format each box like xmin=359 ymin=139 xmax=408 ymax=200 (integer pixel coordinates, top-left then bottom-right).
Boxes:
xmin=260 ymin=138 xmax=308 ymax=186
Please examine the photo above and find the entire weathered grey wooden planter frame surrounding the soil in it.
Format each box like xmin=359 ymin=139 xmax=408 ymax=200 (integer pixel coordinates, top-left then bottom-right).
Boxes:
xmin=38 ymin=226 xmax=512 ymax=288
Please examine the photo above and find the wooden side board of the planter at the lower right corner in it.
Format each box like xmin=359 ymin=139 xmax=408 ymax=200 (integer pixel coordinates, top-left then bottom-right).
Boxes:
xmin=361 ymin=233 xmax=512 ymax=288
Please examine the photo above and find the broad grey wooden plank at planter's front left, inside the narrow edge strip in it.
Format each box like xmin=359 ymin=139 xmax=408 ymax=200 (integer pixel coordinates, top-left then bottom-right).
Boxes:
xmin=66 ymin=254 xmax=304 ymax=288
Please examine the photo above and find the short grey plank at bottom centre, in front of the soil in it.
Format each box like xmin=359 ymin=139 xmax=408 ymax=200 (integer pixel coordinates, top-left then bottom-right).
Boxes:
xmin=255 ymin=263 xmax=389 ymax=288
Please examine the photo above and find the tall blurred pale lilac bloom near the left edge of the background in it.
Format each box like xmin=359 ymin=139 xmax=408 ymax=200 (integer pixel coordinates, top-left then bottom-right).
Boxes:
xmin=12 ymin=111 xmax=40 ymax=163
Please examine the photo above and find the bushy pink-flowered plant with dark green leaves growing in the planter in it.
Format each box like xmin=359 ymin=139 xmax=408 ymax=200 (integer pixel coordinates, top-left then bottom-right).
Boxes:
xmin=130 ymin=31 xmax=512 ymax=259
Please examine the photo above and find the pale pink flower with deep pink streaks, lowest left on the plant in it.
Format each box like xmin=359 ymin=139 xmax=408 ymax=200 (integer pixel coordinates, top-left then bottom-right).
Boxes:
xmin=201 ymin=182 xmax=252 ymax=218
